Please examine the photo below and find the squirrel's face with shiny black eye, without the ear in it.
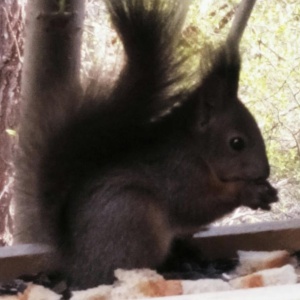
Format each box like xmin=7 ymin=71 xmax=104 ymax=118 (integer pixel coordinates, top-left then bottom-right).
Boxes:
xmin=200 ymin=99 xmax=270 ymax=181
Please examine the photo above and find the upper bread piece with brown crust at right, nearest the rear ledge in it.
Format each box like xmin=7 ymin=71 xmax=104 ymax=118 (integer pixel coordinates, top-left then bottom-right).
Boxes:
xmin=234 ymin=250 xmax=292 ymax=275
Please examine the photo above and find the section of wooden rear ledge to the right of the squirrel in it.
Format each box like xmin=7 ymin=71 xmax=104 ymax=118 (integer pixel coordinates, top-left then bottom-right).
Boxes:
xmin=193 ymin=220 xmax=300 ymax=258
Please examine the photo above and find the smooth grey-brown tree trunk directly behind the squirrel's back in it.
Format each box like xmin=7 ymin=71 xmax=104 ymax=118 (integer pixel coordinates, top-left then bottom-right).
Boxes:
xmin=14 ymin=0 xmax=84 ymax=243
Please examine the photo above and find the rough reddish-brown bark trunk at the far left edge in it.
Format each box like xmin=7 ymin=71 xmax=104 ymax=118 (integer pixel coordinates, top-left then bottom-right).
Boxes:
xmin=0 ymin=0 xmax=24 ymax=245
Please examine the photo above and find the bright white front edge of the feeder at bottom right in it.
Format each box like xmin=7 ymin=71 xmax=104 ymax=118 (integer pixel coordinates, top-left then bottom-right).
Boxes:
xmin=152 ymin=284 xmax=300 ymax=300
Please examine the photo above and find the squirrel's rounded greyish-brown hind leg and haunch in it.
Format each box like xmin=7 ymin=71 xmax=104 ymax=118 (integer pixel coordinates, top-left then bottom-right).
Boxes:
xmin=62 ymin=188 xmax=173 ymax=288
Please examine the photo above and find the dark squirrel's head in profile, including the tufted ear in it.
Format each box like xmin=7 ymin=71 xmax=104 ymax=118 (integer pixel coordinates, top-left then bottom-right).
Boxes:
xmin=194 ymin=48 xmax=270 ymax=181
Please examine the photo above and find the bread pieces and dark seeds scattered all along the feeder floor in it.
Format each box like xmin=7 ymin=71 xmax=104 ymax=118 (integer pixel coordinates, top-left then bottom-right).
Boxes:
xmin=0 ymin=250 xmax=300 ymax=300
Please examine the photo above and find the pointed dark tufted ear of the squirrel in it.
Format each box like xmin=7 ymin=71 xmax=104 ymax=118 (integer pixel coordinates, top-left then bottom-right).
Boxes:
xmin=194 ymin=47 xmax=240 ymax=127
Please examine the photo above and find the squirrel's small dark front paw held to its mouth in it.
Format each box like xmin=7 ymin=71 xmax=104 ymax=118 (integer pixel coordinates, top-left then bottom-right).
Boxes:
xmin=241 ymin=181 xmax=278 ymax=210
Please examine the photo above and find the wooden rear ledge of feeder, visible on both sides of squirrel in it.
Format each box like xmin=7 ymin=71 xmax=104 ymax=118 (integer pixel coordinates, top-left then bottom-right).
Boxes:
xmin=0 ymin=220 xmax=300 ymax=280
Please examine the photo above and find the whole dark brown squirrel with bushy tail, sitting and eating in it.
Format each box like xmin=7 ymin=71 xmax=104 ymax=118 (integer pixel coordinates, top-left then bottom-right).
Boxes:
xmin=13 ymin=0 xmax=277 ymax=288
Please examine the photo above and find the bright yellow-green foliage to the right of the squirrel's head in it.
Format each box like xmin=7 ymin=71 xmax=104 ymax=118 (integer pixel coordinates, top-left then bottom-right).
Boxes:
xmin=241 ymin=1 xmax=300 ymax=182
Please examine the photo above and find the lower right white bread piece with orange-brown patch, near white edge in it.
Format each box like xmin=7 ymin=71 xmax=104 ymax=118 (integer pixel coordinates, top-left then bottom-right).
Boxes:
xmin=229 ymin=265 xmax=297 ymax=289
